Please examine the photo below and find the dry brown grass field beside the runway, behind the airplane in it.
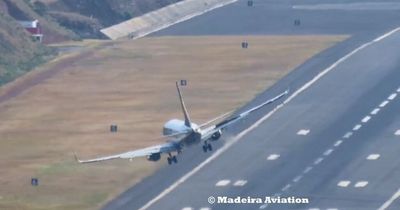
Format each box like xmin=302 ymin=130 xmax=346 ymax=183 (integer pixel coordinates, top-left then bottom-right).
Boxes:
xmin=0 ymin=36 xmax=344 ymax=209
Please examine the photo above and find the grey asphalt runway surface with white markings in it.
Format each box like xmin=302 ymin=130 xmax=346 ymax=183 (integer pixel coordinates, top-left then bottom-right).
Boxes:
xmin=104 ymin=0 xmax=400 ymax=210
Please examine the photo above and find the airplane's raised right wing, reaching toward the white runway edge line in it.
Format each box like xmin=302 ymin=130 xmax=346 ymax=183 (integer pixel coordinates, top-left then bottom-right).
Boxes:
xmin=202 ymin=90 xmax=289 ymax=140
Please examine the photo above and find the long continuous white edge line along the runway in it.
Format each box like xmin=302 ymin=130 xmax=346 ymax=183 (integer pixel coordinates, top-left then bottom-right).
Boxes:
xmin=139 ymin=27 xmax=400 ymax=210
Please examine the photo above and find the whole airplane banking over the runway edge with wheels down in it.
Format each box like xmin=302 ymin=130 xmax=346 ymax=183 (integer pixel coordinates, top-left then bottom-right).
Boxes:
xmin=74 ymin=82 xmax=289 ymax=165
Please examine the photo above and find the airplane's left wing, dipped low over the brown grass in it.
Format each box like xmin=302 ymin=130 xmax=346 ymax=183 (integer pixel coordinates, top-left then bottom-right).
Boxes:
xmin=74 ymin=142 xmax=179 ymax=163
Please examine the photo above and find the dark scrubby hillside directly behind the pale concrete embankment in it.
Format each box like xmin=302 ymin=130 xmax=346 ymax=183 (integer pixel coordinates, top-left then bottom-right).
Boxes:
xmin=41 ymin=0 xmax=181 ymax=38
